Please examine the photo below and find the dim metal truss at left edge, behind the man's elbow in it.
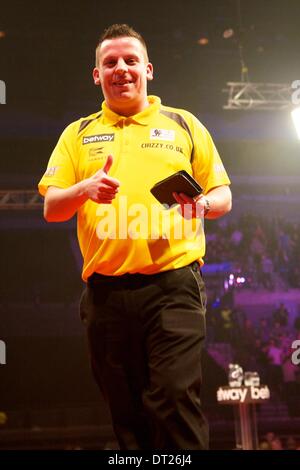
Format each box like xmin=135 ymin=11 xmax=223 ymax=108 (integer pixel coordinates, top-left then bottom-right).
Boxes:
xmin=0 ymin=189 xmax=43 ymax=210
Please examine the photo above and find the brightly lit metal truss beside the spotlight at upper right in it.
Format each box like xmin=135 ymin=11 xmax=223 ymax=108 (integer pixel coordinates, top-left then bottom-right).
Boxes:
xmin=223 ymin=82 xmax=292 ymax=111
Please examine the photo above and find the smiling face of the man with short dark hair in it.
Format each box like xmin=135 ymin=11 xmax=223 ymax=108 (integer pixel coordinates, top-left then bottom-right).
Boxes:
xmin=93 ymin=37 xmax=153 ymax=116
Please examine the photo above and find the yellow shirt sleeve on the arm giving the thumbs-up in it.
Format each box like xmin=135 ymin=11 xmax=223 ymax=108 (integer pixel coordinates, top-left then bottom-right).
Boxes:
xmin=38 ymin=123 xmax=78 ymax=196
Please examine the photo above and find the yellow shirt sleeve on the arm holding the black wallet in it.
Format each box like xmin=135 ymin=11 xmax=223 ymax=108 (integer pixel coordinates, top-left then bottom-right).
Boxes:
xmin=192 ymin=117 xmax=230 ymax=194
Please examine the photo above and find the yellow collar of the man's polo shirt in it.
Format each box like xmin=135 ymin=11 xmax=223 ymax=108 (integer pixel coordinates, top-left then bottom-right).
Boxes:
xmin=102 ymin=96 xmax=161 ymax=126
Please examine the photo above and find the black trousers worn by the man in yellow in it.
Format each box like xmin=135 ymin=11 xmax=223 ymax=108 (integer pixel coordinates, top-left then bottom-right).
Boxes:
xmin=80 ymin=263 xmax=208 ymax=450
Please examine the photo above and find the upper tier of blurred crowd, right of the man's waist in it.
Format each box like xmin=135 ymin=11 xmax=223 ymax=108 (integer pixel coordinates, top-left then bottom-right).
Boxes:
xmin=205 ymin=214 xmax=300 ymax=291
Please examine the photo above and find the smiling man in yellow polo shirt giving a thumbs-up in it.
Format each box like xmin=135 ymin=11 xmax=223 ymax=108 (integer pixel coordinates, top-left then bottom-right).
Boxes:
xmin=39 ymin=25 xmax=231 ymax=449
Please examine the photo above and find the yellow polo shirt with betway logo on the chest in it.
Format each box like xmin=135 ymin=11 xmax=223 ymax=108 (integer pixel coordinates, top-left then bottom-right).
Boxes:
xmin=39 ymin=96 xmax=230 ymax=281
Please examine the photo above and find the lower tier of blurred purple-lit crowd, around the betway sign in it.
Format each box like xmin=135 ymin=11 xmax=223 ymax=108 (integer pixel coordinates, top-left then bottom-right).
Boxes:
xmin=207 ymin=297 xmax=300 ymax=416
